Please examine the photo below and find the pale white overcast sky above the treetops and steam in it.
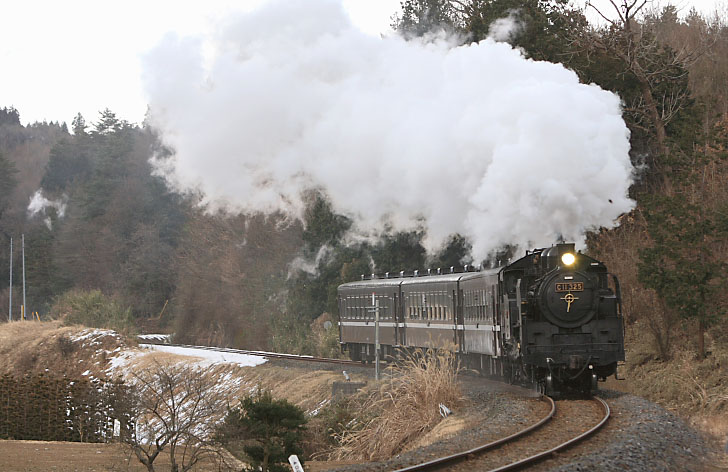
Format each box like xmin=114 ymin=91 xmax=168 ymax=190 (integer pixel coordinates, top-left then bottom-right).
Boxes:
xmin=0 ymin=0 xmax=726 ymax=125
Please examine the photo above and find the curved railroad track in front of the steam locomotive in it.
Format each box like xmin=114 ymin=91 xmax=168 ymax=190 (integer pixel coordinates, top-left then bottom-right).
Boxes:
xmin=396 ymin=397 xmax=610 ymax=472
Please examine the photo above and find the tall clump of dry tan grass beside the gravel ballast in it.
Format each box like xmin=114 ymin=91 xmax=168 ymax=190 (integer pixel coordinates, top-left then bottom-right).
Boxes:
xmin=332 ymin=351 xmax=463 ymax=461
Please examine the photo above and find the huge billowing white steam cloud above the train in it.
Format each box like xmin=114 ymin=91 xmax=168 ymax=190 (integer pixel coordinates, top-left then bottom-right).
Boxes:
xmin=145 ymin=0 xmax=633 ymax=257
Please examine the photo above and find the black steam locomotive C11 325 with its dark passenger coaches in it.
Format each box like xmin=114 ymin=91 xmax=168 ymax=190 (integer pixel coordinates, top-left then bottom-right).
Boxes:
xmin=338 ymin=244 xmax=624 ymax=395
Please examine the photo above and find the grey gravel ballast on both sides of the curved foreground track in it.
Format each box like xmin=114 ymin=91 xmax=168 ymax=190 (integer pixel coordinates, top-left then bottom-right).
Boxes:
xmin=322 ymin=378 xmax=723 ymax=472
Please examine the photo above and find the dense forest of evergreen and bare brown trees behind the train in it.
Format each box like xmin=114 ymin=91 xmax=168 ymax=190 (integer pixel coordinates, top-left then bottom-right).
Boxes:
xmin=0 ymin=0 xmax=728 ymax=378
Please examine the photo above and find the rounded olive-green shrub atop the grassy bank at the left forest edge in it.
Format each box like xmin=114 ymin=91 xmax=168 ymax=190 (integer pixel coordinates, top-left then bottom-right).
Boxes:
xmin=51 ymin=290 xmax=134 ymax=334
